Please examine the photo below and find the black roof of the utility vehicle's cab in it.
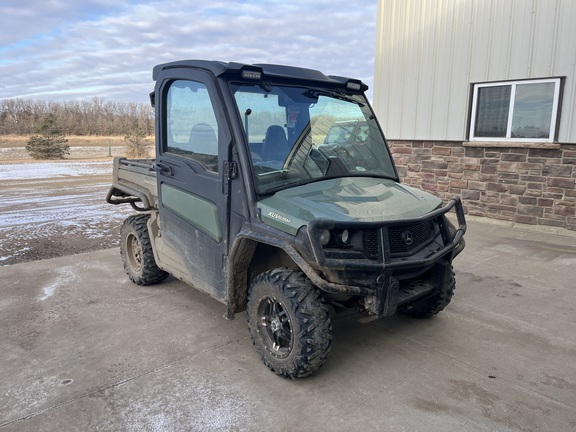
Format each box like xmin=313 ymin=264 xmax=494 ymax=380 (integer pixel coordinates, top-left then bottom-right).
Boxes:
xmin=152 ymin=60 xmax=368 ymax=91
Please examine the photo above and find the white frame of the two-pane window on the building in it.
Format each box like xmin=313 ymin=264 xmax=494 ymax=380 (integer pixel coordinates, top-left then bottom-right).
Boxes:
xmin=468 ymin=78 xmax=562 ymax=142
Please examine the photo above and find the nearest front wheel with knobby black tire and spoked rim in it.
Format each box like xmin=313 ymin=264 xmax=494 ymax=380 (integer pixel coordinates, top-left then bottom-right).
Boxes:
xmin=247 ymin=268 xmax=332 ymax=379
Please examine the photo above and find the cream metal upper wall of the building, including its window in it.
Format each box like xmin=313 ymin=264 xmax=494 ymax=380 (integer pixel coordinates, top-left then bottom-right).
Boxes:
xmin=374 ymin=0 xmax=576 ymax=143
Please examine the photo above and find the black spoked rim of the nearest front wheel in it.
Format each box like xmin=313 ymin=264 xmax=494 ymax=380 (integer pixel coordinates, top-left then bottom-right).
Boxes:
xmin=258 ymin=297 xmax=294 ymax=358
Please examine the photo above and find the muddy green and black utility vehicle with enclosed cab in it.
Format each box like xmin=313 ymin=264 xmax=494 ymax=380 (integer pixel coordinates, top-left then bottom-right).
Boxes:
xmin=107 ymin=60 xmax=466 ymax=378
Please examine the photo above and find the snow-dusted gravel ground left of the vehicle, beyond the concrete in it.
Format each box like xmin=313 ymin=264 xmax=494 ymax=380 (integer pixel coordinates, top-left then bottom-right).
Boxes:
xmin=0 ymin=160 xmax=133 ymax=266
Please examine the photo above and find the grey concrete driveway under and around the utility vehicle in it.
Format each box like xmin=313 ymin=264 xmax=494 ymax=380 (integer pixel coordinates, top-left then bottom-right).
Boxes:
xmin=0 ymin=220 xmax=576 ymax=432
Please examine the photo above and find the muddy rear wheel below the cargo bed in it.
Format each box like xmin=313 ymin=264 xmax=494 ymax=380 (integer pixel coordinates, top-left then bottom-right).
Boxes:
xmin=120 ymin=214 xmax=168 ymax=285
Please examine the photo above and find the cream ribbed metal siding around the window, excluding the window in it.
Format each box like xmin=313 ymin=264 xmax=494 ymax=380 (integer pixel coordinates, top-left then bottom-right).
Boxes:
xmin=374 ymin=0 xmax=576 ymax=143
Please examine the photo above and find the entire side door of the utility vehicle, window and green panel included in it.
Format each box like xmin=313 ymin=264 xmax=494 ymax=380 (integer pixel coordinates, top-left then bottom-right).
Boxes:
xmin=156 ymin=70 xmax=230 ymax=300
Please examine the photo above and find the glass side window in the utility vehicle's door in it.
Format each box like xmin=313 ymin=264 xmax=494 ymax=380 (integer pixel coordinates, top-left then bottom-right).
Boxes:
xmin=164 ymin=80 xmax=218 ymax=172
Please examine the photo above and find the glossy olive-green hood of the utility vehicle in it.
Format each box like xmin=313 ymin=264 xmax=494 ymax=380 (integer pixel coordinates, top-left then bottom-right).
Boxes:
xmin=257 ymin=177 xmax=442 ymax=235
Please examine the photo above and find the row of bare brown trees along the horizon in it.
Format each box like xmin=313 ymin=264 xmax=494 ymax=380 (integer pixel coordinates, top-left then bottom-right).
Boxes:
xmin=0 ymin=97 xmax=154 ymax=136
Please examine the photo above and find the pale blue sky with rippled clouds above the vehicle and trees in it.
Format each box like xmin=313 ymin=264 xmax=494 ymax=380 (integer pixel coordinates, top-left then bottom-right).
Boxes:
xmin=0 ymin=0 xmax=377 ymax=102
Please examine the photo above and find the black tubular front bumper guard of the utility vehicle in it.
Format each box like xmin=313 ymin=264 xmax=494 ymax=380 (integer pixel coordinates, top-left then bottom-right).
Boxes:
xmin=305 ymin=197 xmax=466 ymax=316
